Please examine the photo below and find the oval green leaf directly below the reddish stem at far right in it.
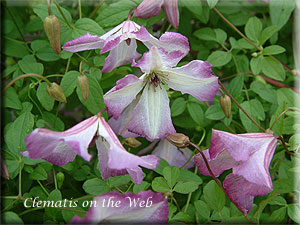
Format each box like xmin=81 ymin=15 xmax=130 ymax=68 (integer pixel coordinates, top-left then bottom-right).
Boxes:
xmin=250 ymin=81 xmax=277 ymax=104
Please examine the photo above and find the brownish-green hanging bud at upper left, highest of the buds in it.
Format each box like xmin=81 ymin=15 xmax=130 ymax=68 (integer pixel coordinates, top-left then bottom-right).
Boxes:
xmin=44 ymin=15 xmax=61 ymax=54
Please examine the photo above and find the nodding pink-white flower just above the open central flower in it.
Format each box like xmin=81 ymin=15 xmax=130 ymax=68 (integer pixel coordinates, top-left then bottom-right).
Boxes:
xmin=63 ymin=20 xmax=150 ymax=73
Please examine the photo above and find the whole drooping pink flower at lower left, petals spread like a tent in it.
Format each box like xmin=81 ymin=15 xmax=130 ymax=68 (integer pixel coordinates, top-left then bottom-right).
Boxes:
xmin=22 ymin=115 xmax=159 ymax=184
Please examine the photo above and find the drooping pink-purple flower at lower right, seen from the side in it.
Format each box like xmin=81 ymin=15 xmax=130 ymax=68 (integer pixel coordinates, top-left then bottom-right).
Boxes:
xmin=194 ymin=130 xmax=277 ymax=215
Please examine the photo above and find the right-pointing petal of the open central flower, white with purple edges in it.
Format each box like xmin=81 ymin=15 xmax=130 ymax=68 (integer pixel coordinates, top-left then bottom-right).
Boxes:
xmin=161 ymin=60 xmax=219 ymax=101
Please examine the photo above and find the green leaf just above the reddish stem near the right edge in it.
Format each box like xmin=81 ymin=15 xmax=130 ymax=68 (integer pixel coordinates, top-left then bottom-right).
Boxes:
xmin=262 ymin=56 xmax=285 ymax=81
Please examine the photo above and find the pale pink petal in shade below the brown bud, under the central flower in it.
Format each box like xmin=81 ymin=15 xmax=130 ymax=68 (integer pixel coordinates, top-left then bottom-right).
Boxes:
xmin=152 ymin=139 xmax=195 ymax=169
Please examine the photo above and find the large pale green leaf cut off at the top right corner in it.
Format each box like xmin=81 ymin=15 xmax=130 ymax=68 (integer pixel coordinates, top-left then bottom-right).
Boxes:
xmin=269 ymin=0 xmax=295 ymax=30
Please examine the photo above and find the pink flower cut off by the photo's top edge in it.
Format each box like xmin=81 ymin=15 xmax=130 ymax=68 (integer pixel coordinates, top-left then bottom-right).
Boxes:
xmin=133 ymin=0 xmax=179 ymax=28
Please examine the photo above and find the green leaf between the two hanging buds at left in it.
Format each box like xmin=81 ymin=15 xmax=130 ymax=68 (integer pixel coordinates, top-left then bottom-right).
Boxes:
xmin=60 ymin=70 xmax=80 ymax=97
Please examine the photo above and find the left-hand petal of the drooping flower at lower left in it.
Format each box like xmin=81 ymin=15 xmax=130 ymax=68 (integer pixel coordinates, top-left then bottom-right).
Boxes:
xmin=23 ymin=116 xmax=98 ymax=166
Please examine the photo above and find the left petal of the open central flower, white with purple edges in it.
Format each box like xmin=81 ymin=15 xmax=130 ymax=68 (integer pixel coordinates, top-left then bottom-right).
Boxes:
xmin=104 ymin=74 xmax=144 ymax=120
